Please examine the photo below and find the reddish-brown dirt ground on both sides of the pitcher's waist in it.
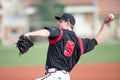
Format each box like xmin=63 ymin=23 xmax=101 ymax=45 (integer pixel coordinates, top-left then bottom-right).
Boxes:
xmin=0 ymin=63 xmax=120 ymax=80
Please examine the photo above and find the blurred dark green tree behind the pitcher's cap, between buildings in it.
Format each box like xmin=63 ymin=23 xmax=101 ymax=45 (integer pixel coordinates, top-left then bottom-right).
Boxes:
xmin=37 ymin=0 xmax=64 ymax=21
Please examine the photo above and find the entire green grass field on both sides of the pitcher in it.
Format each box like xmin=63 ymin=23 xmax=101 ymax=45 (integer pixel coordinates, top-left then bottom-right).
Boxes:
xmin=0 ymin=41 xmax=120 ymax=66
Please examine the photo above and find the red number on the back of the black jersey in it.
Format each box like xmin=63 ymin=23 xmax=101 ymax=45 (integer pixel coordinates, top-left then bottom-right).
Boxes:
xmin=64 ymin=41 xmax=75 ymax=57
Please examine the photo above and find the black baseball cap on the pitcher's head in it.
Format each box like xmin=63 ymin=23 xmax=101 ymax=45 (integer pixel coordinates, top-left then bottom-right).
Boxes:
xmin=55 ymin=13 xmax=75 ymax=26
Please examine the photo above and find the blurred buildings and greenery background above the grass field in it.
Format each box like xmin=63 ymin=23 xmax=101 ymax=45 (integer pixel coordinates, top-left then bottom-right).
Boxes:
xmin=0 ymin=0 xmax=120 ymax=46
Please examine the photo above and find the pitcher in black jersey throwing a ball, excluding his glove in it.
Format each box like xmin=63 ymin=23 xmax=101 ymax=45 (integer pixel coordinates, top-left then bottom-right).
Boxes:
xmin=25 ymin=13 xmax=114 ymax=80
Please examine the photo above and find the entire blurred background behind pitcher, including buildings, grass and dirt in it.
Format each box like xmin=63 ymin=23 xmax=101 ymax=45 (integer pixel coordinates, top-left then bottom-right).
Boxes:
xmin=0 ymin=0 xmax=120 ymax=80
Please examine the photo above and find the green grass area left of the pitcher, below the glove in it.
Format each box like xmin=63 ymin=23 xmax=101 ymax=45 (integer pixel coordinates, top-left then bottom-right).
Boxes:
xmin=0 ymin=43 xmax=48 ymax=66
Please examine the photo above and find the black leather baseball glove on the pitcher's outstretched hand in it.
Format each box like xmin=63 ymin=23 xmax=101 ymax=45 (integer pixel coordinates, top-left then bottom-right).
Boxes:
xmin=16 ymin=35 xmax=34 ymax=55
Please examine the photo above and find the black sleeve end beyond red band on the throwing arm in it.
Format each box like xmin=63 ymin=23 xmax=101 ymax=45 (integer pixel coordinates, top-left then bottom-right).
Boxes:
xmin=82 ymin=38 xmax=97 ymax=53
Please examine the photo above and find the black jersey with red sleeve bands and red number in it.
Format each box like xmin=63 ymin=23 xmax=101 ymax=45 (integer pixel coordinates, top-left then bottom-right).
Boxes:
xmin=46 ymin=28 xmax=97 ymax=72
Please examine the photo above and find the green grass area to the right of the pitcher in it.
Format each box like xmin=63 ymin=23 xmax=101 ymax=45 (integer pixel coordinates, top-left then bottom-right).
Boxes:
xmin=79 ymin=42 xmax=120 ymax=63
